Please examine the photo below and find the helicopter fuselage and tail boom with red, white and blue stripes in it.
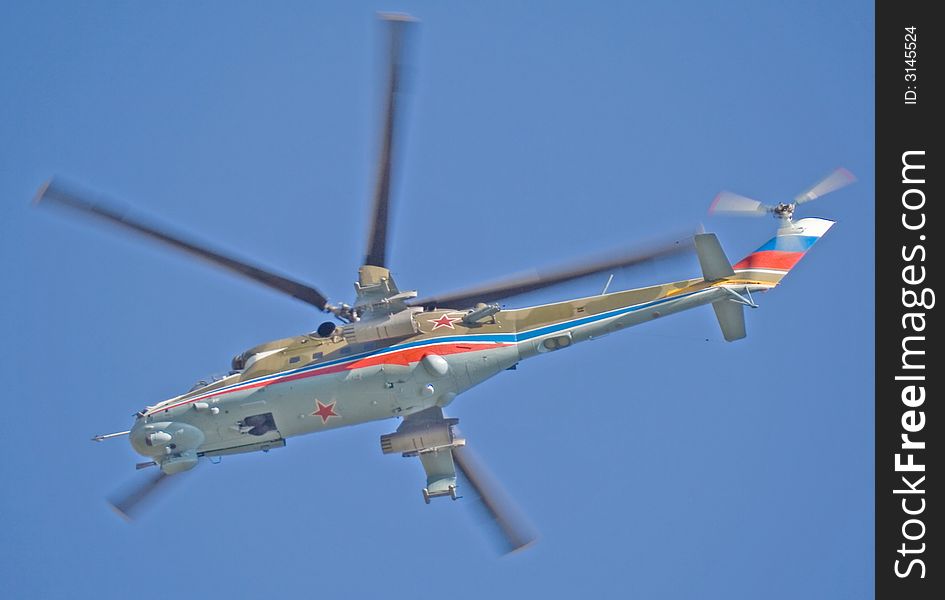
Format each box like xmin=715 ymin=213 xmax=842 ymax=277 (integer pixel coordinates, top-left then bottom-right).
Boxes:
xmin=130 ymin=272 xmax=776 ymax=473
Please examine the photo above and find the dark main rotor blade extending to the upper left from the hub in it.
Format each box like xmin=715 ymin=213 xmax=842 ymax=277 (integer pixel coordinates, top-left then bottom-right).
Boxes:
xmin=33 ymin=179 xmax=328 ymax=310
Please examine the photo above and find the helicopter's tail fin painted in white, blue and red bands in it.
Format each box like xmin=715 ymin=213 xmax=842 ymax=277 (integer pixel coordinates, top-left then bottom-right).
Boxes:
xmin=732 ymin=218 xmax=833 ymax=285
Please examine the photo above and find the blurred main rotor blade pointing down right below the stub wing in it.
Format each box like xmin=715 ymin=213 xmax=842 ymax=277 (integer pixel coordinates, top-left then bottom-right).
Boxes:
xmin=453 ymin=446 xmax=535 ymax=554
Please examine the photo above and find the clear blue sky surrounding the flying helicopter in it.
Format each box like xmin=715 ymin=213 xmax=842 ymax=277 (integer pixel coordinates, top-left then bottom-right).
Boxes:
xmin=0 ymin=1 xmax=874 ymax=599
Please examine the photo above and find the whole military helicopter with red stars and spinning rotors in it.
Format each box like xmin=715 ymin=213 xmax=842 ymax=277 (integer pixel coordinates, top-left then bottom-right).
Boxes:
xmin=34 ymin=14 xmax=852 ymax=550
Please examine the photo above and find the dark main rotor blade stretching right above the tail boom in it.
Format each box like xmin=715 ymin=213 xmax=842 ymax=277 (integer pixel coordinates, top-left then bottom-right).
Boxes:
xmin=407 ymin=236 xmax=693 ymax=309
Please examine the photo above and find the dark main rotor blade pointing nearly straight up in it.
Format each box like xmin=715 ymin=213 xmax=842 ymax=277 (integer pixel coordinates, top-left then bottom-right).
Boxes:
xmin=364 ymin=14 xmax=415 ymax=267
